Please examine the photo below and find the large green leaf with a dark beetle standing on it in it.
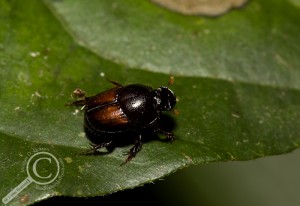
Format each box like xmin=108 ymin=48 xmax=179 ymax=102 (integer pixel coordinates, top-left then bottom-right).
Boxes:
xmin=0 ymin=0 xmax=300 ymax=205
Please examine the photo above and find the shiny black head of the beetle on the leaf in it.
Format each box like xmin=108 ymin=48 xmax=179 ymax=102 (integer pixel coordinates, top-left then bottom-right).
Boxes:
xmin=153 ymin=87 xmax=176 ymax=111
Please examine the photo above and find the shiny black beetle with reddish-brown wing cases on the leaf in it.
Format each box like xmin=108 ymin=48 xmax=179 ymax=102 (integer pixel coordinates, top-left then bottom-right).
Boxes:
xmin=69 ymin=77 xmax=176 ymax=163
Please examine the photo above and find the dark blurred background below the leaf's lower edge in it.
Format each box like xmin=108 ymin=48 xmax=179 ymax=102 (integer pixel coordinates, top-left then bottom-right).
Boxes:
xmin=37 ymin=149 xmax=300 ymax=206
